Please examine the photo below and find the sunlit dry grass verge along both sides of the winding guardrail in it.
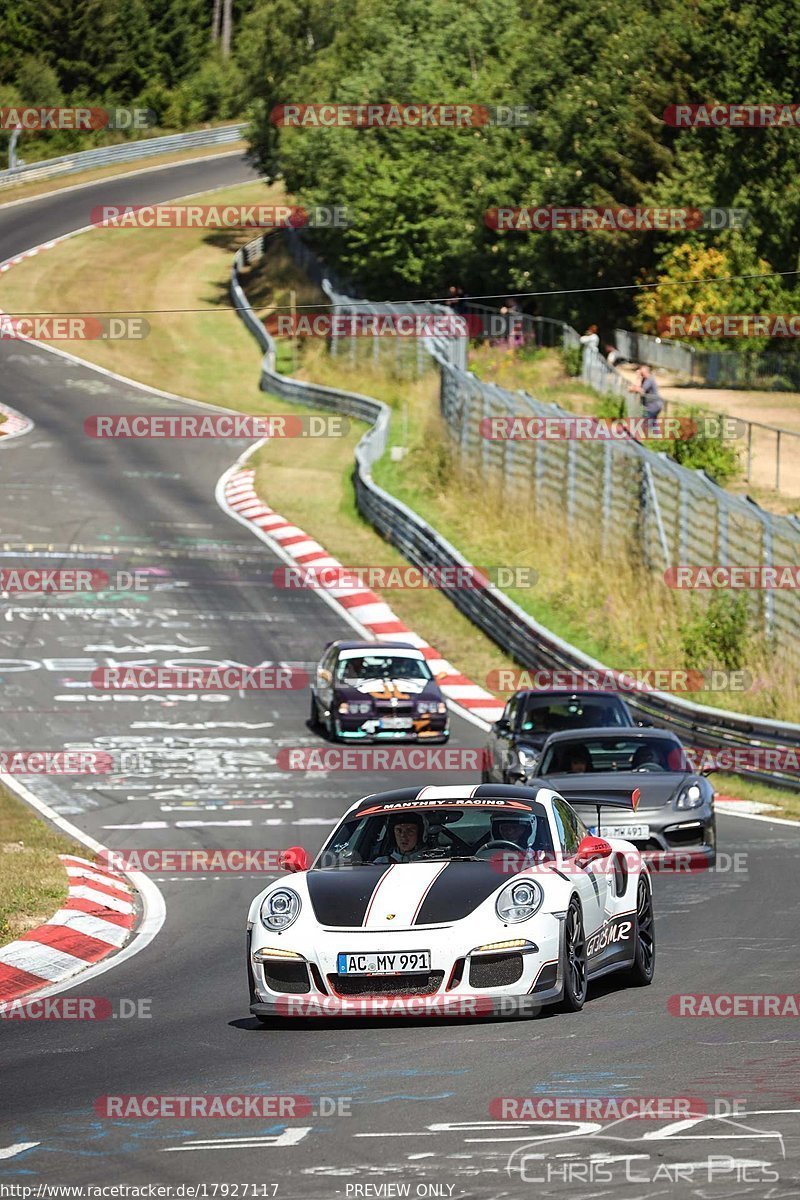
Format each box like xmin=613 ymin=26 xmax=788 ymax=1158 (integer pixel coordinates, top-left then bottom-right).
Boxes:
xmin=0 ymin=177 xmax=800 ymax=805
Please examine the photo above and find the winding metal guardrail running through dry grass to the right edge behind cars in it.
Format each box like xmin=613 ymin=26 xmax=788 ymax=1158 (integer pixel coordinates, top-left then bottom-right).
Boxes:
xmin=230 ymin=239 xmax=800 ymax=787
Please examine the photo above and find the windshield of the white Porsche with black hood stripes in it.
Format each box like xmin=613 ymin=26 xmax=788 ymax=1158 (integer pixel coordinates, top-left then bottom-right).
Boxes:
xmin=314 ymin=800 xmax=553 ymax=869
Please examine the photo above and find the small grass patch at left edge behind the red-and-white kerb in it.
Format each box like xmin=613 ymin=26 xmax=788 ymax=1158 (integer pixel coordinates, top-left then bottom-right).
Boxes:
xmin=0 ymin=787 xmax=78 ymax=946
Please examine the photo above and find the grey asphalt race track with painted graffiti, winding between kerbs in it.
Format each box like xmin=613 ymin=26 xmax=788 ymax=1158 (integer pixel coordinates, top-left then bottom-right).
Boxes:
xmin=0 ymin=156 xmax=800 ymax=1200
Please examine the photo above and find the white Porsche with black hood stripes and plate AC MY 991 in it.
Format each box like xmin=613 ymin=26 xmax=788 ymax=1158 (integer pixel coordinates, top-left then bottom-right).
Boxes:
xmin=247 ymin=784 xmax=655 ymax=1020
